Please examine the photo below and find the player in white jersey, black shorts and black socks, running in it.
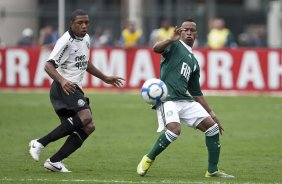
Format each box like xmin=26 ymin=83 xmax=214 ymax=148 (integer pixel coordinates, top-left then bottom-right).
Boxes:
xmin=29 ymin=9 xmax=124 ymax=172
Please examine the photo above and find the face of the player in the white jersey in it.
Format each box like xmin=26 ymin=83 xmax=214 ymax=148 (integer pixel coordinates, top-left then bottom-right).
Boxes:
xmin=71 ymin=15 xmax=89 ymax=37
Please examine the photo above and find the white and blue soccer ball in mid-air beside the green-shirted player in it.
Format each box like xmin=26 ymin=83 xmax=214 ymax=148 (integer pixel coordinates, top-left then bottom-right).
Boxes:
xmin=141 ymin=79 xmax=167 ymax=105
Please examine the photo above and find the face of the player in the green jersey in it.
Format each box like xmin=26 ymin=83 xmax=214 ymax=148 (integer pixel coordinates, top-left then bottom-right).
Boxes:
xmin=181 ymin=22 xmax=198 ymax=47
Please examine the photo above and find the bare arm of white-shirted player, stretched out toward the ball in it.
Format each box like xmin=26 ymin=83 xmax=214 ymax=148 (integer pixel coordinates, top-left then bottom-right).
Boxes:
xmin=86 ymin=61 xmax=125 ymax=87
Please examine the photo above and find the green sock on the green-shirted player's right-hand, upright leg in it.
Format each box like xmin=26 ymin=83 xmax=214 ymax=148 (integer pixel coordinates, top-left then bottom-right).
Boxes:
xmin=206 ymin=134 xmax=220 ymax=173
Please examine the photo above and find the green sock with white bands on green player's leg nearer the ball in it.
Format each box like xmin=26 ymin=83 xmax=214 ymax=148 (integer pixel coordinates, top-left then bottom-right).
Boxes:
xmin=147 ymin=131 xmax=175 ymax=160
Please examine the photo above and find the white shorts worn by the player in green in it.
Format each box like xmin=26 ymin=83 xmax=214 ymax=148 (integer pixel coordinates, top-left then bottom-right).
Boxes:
xmin=156 ymin=100 xmax=210 ymax=132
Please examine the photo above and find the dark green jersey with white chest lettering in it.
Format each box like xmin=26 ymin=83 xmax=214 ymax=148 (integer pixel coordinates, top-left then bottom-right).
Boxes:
xmin=160 ymin=41 xmax=203 ymax=101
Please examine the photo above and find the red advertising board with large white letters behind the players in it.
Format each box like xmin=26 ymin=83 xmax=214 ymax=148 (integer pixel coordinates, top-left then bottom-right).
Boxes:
xmin=0 ymin=47 xmax=282 ymax=92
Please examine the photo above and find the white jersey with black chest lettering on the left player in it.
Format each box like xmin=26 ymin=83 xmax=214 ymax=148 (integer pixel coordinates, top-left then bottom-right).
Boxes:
xmin=48 ymin=30 xmax=90 ymax=88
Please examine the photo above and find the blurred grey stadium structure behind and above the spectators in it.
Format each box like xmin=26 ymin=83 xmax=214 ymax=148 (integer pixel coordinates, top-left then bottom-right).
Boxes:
xmin=0 ymin=0 xmax=281 ymax=47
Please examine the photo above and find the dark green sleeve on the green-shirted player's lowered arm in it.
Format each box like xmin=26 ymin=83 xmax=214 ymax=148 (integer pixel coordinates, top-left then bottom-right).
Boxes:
xmin=188 ymin=70 xmax=203 ymax=96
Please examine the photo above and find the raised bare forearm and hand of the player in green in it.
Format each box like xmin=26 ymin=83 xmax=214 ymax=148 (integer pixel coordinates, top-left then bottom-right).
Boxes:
xmin=153 ymin=26 xmax=185 ymax=54
